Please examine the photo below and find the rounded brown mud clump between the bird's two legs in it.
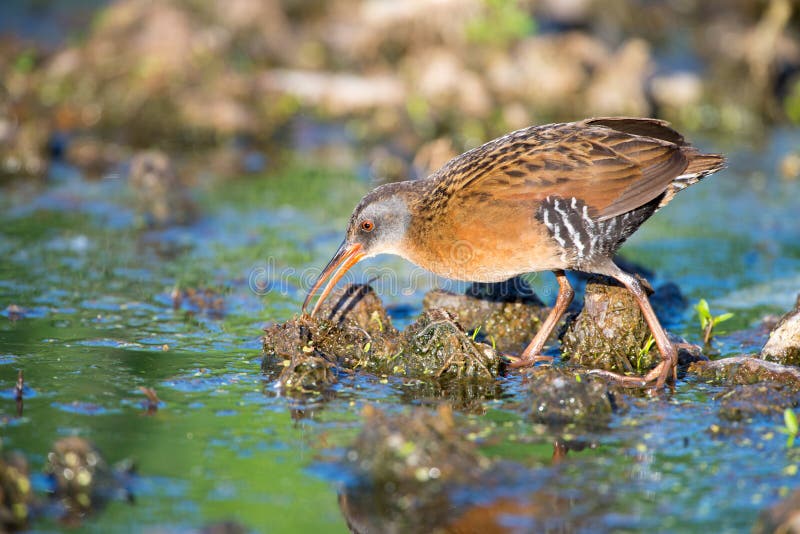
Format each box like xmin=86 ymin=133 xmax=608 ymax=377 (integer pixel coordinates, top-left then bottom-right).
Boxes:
xmin=561 ymin=277 xmax=659 ymax=373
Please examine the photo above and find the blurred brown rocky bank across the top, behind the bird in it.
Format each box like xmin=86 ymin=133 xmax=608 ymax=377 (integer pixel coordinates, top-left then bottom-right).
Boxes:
xmin=0 ymin=0 xmax=800 ymax=184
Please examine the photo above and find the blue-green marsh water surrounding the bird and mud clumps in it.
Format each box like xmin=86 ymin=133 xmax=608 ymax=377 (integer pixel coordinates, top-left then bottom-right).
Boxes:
xmin=0 ymin=130 xmax=800 ymax=532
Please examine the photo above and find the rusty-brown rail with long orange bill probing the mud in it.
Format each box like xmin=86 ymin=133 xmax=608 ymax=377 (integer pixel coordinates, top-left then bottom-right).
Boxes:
xmin=302 ymin=117 xmax=726 ymax=389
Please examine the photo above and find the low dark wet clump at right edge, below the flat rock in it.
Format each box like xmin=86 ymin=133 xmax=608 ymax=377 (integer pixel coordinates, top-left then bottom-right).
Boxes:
xmin=716 ymin=382 xmax=798 ymax=421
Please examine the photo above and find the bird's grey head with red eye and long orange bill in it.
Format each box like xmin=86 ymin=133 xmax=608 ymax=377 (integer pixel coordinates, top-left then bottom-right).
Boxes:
xmin=303 ymin=182 xmax=413 ymax=317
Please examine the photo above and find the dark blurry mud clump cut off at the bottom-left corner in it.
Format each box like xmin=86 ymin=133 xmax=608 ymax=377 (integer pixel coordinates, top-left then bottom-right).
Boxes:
xmin=0 ymin=454 xmax=33 ymax=532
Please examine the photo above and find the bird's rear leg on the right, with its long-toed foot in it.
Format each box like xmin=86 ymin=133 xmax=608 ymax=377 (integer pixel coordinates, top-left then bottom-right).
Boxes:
xmin=592 ymin=262 xmax=678 ymax=389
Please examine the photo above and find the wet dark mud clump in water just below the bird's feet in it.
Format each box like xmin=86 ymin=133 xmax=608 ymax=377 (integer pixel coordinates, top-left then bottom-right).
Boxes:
xmin=525 ymin=367 xmax=625 ymax=427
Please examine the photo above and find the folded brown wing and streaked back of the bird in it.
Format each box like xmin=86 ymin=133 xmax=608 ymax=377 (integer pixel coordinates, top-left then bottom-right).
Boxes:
xmin=431 ymin=118 xmax=688 ymax=219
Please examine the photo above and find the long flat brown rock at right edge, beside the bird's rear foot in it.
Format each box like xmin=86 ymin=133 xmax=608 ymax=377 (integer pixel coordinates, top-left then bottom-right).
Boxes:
xmin=687 ymin=356 xmax=800 ymax=390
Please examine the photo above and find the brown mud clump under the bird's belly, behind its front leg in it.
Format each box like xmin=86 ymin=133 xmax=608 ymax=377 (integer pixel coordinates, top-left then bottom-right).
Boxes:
xmin=422 ymin=277 xmax=548 ymax=353
